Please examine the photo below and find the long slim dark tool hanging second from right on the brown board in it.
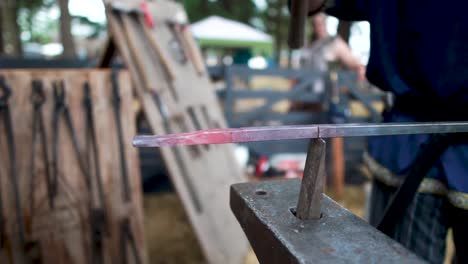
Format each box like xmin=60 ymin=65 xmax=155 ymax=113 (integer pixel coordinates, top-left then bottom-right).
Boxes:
xmin=83 ymin=82 xmax=109 ymax=264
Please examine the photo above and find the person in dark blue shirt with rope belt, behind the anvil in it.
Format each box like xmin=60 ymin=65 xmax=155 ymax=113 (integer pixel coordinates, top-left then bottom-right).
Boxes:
xmin=308 ymin=0 xmax=468 ymax=263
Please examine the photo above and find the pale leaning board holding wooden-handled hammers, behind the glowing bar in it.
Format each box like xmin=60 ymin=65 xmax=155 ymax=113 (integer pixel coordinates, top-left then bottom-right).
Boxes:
xmin=101 ymin=0 xmax=249 ymax=263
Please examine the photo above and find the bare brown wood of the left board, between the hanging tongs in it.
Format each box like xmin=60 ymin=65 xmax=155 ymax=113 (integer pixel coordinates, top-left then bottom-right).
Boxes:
xmin=0 ymin=70 xmax=145 ymax=263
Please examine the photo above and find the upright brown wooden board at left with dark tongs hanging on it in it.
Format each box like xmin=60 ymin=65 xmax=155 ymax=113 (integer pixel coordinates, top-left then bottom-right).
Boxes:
xmin=0 ymin=69 xmax=146 ymax=264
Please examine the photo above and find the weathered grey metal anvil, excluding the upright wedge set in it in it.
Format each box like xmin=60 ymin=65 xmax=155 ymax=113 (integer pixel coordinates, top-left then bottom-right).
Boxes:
xmin=230 ymin=180 xmax=425 ymax=264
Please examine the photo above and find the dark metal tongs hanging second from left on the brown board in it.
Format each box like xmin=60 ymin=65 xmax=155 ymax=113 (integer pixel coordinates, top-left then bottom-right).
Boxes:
xmin=29 ymin=80 xmax=53 ymax=211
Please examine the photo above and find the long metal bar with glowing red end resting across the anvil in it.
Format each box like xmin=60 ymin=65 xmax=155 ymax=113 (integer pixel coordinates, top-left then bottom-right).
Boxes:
xmin=133 ymin=122 xmax=468 ymax=147
